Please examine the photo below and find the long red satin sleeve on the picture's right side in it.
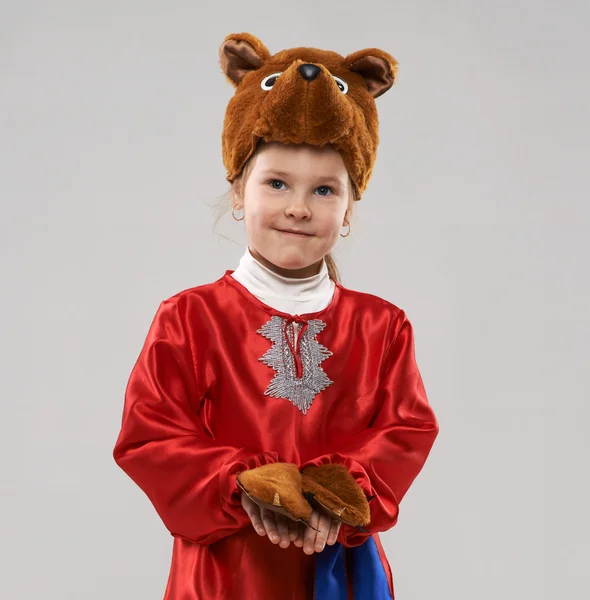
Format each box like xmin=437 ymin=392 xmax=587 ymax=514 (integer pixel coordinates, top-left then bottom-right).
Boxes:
xmin=301 ymin=311 xmax=439 ymax=547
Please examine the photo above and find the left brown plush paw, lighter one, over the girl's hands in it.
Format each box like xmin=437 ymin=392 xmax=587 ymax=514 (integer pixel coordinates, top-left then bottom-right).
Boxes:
xmin=236 ymin=463 xmax=313 ymax=525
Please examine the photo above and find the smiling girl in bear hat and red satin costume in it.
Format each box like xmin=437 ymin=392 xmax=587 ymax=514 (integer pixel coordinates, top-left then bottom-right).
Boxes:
xmin=114 ymin=33 xmax=438 ymax=600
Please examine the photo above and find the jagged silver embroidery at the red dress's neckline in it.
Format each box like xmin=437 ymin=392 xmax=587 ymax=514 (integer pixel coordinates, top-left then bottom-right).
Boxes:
xmin=258 ymin=315 xmax=334 ymax=415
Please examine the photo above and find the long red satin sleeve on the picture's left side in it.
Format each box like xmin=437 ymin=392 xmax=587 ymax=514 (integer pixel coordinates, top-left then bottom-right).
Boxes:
xmin=113 ymin=301 xmax=283 ymax=544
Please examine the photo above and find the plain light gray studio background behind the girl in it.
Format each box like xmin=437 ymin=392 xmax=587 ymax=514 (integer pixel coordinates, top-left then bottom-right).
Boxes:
xmin=0 ymin=0 xmax=590 ymax=600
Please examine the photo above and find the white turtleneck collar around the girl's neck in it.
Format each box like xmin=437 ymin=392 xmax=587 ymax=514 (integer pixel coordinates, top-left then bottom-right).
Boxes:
xmin=232 ymin=248 xmax=335 ymax=315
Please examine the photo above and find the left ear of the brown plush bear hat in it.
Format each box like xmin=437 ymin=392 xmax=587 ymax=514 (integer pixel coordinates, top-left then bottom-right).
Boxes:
xmin=219 ymin=33 xmax=270 ymax=87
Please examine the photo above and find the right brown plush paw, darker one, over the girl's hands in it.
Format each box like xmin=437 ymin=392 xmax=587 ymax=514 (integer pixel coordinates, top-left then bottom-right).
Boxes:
xmin=301 ymin=464 xmax=371 ymax=529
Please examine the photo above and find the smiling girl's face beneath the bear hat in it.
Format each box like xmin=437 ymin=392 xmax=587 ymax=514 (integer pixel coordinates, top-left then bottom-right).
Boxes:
xmin=236 ymin=142 xmax=351 ymax=276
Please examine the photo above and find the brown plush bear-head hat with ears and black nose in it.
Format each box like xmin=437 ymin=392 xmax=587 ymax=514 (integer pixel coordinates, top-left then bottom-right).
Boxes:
xmin=219 ymin=33 xmax=398 ymax=200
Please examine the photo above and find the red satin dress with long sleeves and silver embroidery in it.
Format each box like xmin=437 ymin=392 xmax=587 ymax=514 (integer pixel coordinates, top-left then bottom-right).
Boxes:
xmin=113 ymin=271 xmax=438 ymax=600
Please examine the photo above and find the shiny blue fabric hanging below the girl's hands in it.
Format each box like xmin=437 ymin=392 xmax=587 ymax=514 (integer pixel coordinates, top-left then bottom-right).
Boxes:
xmin=314 ymin=537 xmax=392 ymax=600
